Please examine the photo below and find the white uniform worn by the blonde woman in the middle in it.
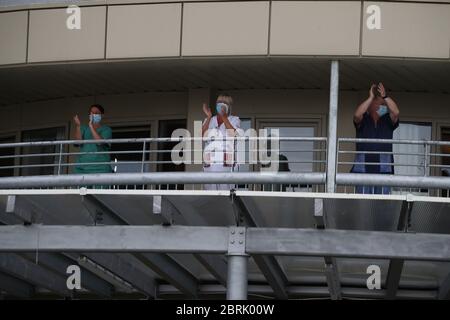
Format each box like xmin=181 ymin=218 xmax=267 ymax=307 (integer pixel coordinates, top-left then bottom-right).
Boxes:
xmin=203 ymin=115 xmax=241 ymax=171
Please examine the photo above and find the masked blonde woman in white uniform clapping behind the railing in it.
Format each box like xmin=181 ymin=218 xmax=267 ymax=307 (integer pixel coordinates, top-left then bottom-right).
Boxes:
xmin=202 ymin=94 xmax=241 ymax=190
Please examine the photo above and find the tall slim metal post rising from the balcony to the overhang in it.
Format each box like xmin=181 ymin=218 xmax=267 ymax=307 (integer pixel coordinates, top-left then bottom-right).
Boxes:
xmin=327 ymin=60 xmax=339 ymax=192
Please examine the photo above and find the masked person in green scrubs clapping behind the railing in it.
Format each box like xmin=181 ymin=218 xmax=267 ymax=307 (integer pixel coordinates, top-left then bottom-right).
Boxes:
xmin=73 ymin=104 xmax=113 ymax=174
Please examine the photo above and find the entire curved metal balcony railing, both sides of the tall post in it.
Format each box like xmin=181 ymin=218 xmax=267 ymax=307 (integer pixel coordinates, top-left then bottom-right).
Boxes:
xmin=0 ymin=137 xmax=450 ymax=197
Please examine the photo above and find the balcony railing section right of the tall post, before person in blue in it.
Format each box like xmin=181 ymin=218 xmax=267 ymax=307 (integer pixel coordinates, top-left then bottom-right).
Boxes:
xmin=336 ymin=138 xmax=450 ymax=197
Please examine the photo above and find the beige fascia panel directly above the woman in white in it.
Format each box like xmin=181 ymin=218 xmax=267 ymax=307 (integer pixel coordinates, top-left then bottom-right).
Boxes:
xmin=182 ymin=1 xmax=269 ymax=56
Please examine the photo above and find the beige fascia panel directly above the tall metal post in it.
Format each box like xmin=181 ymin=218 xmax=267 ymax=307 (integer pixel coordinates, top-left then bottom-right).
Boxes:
xmin=270 ymin=1 xmax=361 ymax=55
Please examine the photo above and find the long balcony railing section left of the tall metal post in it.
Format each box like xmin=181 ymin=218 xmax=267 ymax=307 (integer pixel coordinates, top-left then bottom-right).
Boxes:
xmin=0 ymin=137 xmax=327 ymax=192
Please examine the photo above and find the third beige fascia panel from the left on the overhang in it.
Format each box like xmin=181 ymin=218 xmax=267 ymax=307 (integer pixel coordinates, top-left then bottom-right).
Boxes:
xmin=106 ymin=3 xmax=181 ymax=58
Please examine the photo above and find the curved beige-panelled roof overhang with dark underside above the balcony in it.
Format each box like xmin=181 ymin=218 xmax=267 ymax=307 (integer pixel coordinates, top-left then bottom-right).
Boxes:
xmin=0 ymin=0 xmax=450 ymax=105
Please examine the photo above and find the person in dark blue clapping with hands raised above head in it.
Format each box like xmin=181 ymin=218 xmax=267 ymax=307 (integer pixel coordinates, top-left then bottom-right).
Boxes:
xmin=351 ymin=82 xmax=400 ymax=194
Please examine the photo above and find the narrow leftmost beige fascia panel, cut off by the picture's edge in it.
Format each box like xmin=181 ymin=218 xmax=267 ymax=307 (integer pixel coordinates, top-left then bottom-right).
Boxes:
xmin=0 ymin=11 xmax=28 ymax=64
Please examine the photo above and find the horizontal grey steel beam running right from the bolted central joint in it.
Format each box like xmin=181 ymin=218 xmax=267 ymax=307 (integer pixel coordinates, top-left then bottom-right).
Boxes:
xmin=246 ymin=228 xmax=450 ymax=261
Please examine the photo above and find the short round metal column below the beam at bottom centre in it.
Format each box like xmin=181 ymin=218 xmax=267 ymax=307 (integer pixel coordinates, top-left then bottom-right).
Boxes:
xmin=227 ymin=255 xmax=248 ymax=300
